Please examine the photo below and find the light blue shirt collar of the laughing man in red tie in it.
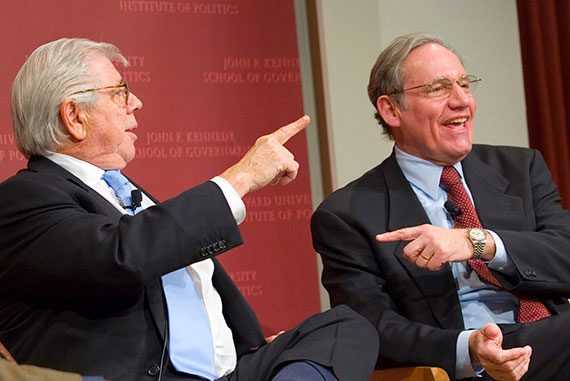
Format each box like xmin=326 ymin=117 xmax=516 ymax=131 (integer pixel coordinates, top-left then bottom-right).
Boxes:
xmin=394 ymin=146 xmax=463 ymax=199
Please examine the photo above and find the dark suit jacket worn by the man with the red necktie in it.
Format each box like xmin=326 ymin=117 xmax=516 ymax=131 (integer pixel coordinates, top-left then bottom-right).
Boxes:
xmin=311 ymin=145 xmax=570 ymax=379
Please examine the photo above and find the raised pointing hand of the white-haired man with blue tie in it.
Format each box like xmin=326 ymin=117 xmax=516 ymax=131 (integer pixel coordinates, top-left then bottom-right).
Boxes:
xmin=220 ymin=115 xmax=310 ymax=197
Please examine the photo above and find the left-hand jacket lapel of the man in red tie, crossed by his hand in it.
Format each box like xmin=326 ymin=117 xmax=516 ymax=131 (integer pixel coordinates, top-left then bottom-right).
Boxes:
xmin=383 ymin=153 xmax=463 ymax=328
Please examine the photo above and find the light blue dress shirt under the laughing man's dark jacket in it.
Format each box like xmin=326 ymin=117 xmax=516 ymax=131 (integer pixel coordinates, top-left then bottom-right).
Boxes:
xmin=395 ymin=147 xmax=519 ymax=378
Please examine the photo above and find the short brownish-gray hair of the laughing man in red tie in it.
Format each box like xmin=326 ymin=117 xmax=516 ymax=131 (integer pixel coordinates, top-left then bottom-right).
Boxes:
xmin=368 ymin=33 xmax=461 ymax=139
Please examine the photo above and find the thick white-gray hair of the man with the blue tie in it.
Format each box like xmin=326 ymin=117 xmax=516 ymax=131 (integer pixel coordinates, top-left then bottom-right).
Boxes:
xmin=11 ymin=38 xmax=127 ymax=158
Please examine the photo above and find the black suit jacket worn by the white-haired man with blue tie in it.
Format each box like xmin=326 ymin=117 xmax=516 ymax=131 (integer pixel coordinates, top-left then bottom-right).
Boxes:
xmin=0 ymin=157 xmax=265 ymax=380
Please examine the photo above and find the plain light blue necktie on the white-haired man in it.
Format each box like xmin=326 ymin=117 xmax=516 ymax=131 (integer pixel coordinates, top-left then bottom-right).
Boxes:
xmin=102 ymin=170 xmax=217 ymax=380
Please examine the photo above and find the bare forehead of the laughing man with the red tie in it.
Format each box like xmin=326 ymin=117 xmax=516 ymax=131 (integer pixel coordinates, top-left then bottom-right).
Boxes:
xmin=403 ymin=43 xmax=466 ymax=86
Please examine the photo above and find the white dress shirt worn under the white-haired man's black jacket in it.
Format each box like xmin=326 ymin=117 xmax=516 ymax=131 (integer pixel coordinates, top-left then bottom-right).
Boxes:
xmin=42 ymin=153 xmax=245 ymax=377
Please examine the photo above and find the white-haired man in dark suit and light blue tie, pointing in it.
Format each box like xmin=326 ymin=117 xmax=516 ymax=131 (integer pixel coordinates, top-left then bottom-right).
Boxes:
xmin=0 ymin=39 xmax=378 ymax=381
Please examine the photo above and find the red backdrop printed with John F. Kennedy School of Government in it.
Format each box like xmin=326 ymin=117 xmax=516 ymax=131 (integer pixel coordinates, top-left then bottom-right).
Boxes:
xmin=0 ymin=0 xmax=319 ymax=333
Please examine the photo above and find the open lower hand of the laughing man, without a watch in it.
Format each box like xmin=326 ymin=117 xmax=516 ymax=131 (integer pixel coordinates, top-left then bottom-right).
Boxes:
xmin=469 ymin=324 xmax=532 ymax=381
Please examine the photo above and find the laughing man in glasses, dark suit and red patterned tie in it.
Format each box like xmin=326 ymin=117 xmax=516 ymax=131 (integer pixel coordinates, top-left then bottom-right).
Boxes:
xmin=311 ymin=34 xmax=570 ymax=380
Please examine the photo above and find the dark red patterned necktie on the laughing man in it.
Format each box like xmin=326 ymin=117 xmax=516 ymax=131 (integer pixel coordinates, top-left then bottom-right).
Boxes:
xmin=441 ymin=167 xmax=550 ymax=323
